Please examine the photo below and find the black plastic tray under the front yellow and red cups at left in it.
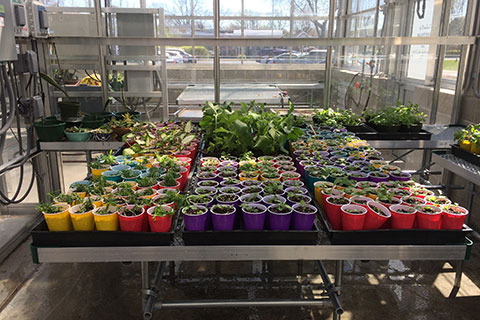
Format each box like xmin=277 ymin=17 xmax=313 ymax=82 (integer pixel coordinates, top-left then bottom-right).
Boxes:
xmin=31 ymin=214 xmax=178 ymax=247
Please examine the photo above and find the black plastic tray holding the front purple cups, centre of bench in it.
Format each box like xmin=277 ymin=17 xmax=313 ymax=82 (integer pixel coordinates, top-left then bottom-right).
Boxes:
xmin=182 ymin=219 xmax=320 ymax=246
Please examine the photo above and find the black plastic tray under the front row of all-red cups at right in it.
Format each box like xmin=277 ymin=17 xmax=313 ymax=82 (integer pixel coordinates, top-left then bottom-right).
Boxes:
xmin=316 ymin=199 xmax=472 ymax=245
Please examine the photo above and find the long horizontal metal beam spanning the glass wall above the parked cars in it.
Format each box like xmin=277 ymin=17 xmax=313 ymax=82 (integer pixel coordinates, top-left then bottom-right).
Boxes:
xmin=48 ymin=36 xmax=477 ymax=47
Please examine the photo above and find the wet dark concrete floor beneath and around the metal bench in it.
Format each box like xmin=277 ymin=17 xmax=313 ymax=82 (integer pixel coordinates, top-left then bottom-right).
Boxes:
xmin=0 ymin=240 xmax=480 ymax=320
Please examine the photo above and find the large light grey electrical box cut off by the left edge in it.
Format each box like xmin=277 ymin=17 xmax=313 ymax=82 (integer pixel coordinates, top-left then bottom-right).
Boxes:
xmin=0 ymin=0 xmax=17 ymax=61
